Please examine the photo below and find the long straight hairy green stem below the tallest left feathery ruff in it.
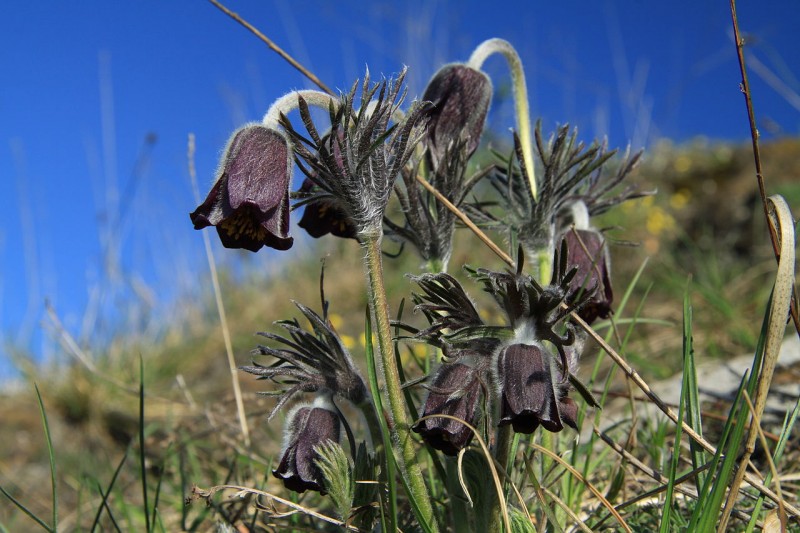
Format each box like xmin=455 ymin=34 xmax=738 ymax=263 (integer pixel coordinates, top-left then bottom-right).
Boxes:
xmin=360 ymin=234 xmax=438 ymax=531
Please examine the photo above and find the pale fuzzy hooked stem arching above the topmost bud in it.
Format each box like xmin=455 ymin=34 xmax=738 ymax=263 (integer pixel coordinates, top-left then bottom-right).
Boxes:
xmin=467 ymin=39 xmax=538 ymax=200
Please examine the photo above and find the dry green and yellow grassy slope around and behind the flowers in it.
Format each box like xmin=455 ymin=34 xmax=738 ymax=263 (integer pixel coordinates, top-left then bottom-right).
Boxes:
xmin=0 ymin=136 xmax=800 ymax=531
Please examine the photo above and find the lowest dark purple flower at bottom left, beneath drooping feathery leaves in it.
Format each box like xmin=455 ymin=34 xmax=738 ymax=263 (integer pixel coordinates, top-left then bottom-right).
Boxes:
xmin=272 ymin=405 xmax=341 ymax=494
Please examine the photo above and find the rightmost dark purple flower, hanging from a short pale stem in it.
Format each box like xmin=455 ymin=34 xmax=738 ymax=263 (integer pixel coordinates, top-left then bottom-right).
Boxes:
xmin=563 ymin=228 xmax=614 ymax=324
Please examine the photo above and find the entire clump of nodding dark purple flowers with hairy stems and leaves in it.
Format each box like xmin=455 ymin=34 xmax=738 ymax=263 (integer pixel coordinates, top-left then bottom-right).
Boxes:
xmin=190 ymin=39 xmax=647 ymax=530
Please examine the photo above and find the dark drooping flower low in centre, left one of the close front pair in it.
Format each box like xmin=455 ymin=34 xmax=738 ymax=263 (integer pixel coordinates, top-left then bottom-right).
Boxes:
xmin=412 ymin=363 xmax=482 ymax=455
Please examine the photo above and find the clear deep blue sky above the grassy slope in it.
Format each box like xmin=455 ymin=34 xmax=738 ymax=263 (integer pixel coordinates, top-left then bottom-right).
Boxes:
xmin=0 ymin=0 xmax=800 ymax=376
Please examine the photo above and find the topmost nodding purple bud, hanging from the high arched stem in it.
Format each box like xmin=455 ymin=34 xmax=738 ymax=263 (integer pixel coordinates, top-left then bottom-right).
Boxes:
xmin=422 ymin=63 xmax=492 ymax=167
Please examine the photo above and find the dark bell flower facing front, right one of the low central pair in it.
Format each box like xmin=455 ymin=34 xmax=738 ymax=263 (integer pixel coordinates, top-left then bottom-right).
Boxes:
xmin=497 ymin=344 xmax=577 ymax=433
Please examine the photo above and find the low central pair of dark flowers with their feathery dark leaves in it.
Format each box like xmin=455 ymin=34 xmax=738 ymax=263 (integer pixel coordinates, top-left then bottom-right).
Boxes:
xmin=407 ymin=245 xmax=595 ymax=455
